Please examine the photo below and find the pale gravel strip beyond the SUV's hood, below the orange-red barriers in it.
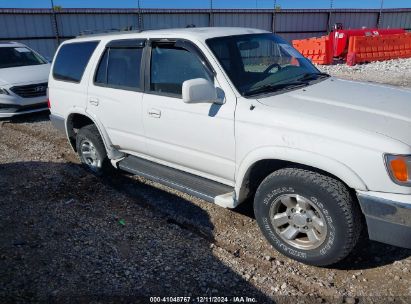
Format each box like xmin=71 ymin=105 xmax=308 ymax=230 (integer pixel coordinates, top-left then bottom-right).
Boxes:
xmin=318 ymin=58 xmax=411 ymax=87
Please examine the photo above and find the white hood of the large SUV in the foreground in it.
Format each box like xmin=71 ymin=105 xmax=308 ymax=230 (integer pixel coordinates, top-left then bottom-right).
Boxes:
xmin=258 ymin=78 xmax=411 ymax=146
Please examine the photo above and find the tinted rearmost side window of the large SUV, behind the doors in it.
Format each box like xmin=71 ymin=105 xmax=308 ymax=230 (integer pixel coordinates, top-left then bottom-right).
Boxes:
xmin=53 ymin=41 xmax=99 ymax=83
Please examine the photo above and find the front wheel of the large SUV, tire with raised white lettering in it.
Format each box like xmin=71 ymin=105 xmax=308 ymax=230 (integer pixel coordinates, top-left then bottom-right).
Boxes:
xmin=254 ymin=168 xmax=362 ymax=266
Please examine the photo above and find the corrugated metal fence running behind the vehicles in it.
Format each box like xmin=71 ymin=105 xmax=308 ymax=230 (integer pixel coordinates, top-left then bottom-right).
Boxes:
xmin=0 ymin=9 xmax=411 ymax=58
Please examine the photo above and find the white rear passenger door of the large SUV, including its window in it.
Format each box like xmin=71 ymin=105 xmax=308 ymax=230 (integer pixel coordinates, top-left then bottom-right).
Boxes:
xmin=87 ymin=39 xmax=146 ymax=153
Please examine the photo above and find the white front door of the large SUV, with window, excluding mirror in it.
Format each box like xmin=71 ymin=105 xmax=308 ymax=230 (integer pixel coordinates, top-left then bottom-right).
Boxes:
xmin=143 ymin=42 xmax=236 ymax=185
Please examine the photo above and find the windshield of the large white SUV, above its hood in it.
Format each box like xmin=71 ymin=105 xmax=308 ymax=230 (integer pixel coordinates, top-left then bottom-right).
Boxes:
xmin=207 ymin=33 xmax=328 ymax=96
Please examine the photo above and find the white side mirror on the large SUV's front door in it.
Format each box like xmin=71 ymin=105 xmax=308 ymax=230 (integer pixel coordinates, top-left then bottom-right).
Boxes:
xmin=183 ymin=78 xmax=222 ymax=104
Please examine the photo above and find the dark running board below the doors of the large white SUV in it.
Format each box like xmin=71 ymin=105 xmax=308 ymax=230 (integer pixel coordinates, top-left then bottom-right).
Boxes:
xmin=117 ymin=155 xmax=235 ymax=208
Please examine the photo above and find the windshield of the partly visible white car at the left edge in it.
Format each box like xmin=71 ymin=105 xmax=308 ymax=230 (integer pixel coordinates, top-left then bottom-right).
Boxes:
xmin=0 ymin=47 xmax=47 ymax=69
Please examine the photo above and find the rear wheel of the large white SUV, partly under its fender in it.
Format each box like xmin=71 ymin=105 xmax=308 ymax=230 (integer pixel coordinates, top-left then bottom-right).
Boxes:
xmin=76 ymin=125 xmax=112 ymax=176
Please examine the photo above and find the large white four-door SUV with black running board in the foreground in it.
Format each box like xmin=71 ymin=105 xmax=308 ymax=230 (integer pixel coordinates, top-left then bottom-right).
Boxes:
xmin=49 ymin=28 xmax=411 ymax=265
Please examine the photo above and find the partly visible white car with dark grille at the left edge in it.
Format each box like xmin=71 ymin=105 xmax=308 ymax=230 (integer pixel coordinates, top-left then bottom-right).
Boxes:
xmin=0 ymin=42 xmax=50 ymax=118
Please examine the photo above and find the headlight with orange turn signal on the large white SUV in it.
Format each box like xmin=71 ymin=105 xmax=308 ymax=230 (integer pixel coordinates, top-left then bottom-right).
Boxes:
xmin=385 ymin=154 xmax=411 ymax=186
